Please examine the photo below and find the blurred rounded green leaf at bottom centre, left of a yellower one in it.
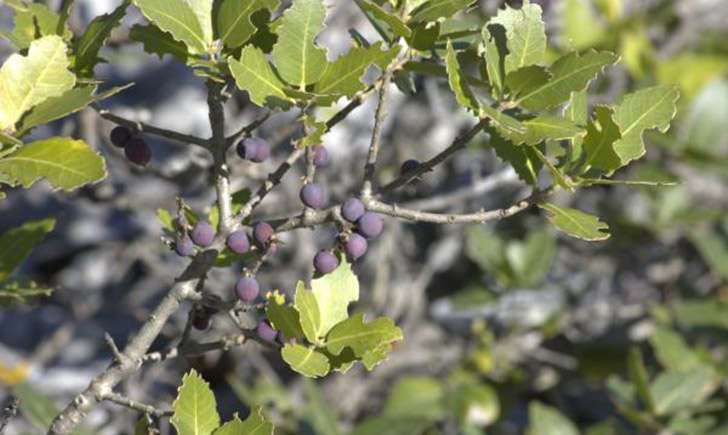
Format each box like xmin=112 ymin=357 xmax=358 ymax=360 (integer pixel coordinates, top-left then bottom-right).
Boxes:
xmin=384 ymin=376 xmax=445 ymax=420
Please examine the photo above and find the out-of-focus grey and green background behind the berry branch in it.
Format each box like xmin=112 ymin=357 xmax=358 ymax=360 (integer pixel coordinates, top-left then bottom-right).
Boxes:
xmin=0 ymin=0 xmax=728 ymax=435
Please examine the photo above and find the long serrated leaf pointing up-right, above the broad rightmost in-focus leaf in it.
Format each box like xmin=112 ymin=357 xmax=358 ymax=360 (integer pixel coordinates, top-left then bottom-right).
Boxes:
xmin=514 ymin=50 xmax=618 ymax=111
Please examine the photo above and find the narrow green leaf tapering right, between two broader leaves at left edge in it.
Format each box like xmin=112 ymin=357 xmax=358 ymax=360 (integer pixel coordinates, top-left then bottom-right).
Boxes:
xmin=18 ymin=83 xmax=133 ymax=136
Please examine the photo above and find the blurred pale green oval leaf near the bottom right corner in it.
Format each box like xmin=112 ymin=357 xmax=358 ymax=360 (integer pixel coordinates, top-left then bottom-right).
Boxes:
xmin=650 ymin=365 xmax=720 ymax=415
